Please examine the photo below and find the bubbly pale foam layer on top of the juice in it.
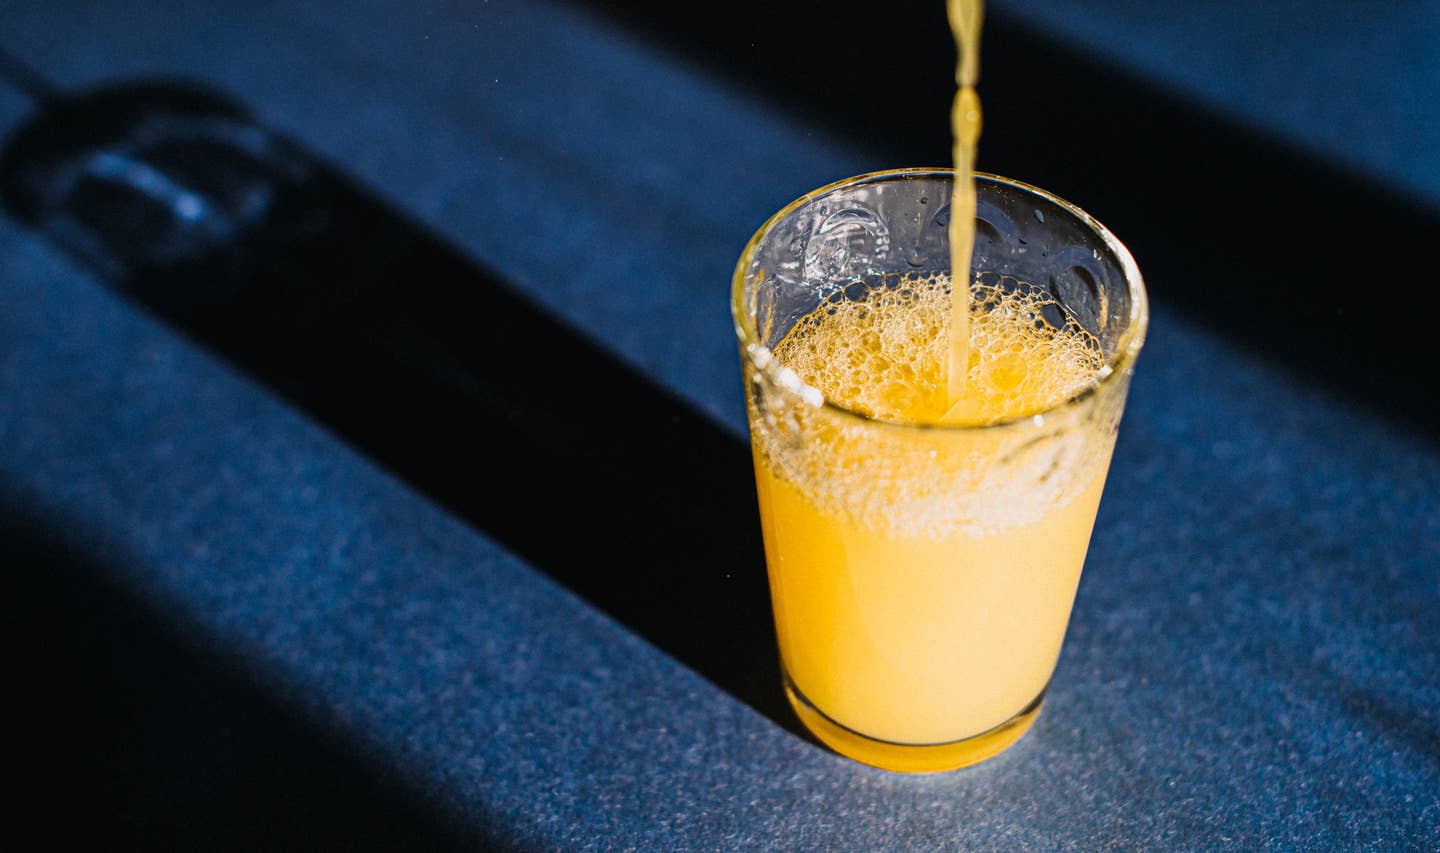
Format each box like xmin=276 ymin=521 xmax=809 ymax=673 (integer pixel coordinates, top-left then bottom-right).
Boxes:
xmin=755 ymin=272 xmax=1109 ymax=539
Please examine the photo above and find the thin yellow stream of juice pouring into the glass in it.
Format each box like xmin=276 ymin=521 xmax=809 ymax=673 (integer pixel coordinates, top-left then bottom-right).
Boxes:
xmin=943 ymin=0 xmax=982 ymax=421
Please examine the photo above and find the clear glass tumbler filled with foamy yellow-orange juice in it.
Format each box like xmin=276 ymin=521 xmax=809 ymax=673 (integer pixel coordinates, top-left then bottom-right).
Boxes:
xmin=733 ymin=169 xmax=1148 ymax=772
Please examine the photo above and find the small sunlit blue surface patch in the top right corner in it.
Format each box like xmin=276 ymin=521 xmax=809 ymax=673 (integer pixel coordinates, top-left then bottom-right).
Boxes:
xmin=991 ymin=0 xmax=1440 ymax=207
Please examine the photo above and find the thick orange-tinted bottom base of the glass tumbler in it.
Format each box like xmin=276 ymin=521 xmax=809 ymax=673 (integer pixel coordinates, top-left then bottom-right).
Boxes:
xmin=785 ymin=673 xmax=1045 ymax=772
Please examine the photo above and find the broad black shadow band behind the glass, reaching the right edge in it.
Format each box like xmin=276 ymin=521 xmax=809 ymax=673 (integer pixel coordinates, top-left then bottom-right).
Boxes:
xmin=575 ymin=0 xmax=1440 ymax=441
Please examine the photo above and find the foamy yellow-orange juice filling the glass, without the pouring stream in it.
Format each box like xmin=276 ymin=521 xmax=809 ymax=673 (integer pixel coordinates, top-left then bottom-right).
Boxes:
xmin=750 ymin=274 xmax=1113 ymax=769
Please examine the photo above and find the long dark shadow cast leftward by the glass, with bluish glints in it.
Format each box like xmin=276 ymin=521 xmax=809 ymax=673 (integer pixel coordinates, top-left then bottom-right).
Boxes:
xmin=0 ymin=84 xmax=799 ymax=732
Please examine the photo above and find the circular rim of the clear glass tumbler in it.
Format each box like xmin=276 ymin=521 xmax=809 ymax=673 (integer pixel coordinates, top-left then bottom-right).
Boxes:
xmin=730 ymin=167 xmax=1149 ymax=432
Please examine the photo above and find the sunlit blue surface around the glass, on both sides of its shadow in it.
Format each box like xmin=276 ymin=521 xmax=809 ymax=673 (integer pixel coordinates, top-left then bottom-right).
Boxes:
xmin=0 ymin=3 xmax=1440 ymax=850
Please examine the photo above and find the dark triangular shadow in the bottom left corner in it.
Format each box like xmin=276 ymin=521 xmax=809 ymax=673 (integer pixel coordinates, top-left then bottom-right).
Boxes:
xmin=0 ymin=514 xmax=517 ymax=850
